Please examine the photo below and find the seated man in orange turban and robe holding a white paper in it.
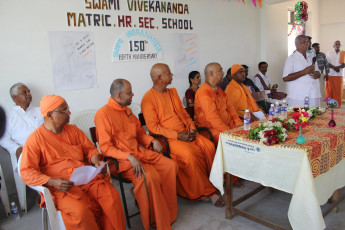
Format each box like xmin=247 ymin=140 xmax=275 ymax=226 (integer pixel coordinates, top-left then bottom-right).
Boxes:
xmin=20 ymin=95 xmax=126 ymax=230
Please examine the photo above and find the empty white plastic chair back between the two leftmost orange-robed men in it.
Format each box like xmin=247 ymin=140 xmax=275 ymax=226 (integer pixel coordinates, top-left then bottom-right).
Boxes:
xmin=70 ymin=110 xmax=97 ymax=140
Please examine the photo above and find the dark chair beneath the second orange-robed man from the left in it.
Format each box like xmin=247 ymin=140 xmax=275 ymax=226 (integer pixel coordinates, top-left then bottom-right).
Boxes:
xmin=90 ymin=127 xmax=140 ymax=228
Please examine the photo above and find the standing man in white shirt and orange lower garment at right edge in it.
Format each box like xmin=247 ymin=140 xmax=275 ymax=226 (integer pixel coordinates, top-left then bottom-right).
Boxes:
xmin=325 ymin=41 xmax=345 ymax=108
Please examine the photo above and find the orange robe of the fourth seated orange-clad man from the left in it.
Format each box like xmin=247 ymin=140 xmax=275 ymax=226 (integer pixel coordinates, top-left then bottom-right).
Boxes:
xmin=194 ymin=82 xmax=243 ymax=146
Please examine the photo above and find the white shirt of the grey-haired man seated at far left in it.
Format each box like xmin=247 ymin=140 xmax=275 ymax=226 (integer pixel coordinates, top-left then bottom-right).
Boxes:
xmin=0 ymin=105 xmax=44 ymax=152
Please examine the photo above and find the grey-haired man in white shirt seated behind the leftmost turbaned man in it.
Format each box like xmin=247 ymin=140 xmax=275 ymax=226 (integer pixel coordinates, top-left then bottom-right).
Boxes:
xmin=0 ymin=83 xmax=44 ymax=211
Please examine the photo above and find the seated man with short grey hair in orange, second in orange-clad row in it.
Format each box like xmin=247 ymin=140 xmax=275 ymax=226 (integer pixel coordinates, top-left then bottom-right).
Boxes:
xmin=95 ymin=79 xmax=178 ymax=230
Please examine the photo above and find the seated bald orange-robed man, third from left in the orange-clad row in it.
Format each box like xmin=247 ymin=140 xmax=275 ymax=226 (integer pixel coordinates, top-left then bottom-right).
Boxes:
xmin=141 ymin=64 xmax=224 ymax=206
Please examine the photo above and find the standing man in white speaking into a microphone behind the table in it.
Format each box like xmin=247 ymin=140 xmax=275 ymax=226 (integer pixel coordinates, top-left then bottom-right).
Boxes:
xmin=283 ymin=35 xmax=321 ymax=107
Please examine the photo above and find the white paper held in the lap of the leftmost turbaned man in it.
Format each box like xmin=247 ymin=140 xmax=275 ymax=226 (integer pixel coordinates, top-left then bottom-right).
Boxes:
xmin=69 ymin=162 xmax=107 ymax=186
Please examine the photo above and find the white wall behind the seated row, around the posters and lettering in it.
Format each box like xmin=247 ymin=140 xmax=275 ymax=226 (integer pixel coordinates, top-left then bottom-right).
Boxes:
xmin=0 ymin=0 xmax=261 ymax=113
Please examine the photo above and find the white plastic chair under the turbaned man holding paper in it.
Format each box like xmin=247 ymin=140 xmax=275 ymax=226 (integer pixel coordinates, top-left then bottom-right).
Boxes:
xmin=18 ymin=156 xmax=66 ymax=230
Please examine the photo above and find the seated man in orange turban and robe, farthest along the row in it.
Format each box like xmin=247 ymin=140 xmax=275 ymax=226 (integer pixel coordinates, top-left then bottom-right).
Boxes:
xmin=225 ymin=64 xmax=263 ymax=120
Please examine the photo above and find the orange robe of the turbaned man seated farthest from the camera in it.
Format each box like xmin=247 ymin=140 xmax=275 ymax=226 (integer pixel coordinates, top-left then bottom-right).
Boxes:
xmin=225 ymin=80 xmax=263 ymax=119
